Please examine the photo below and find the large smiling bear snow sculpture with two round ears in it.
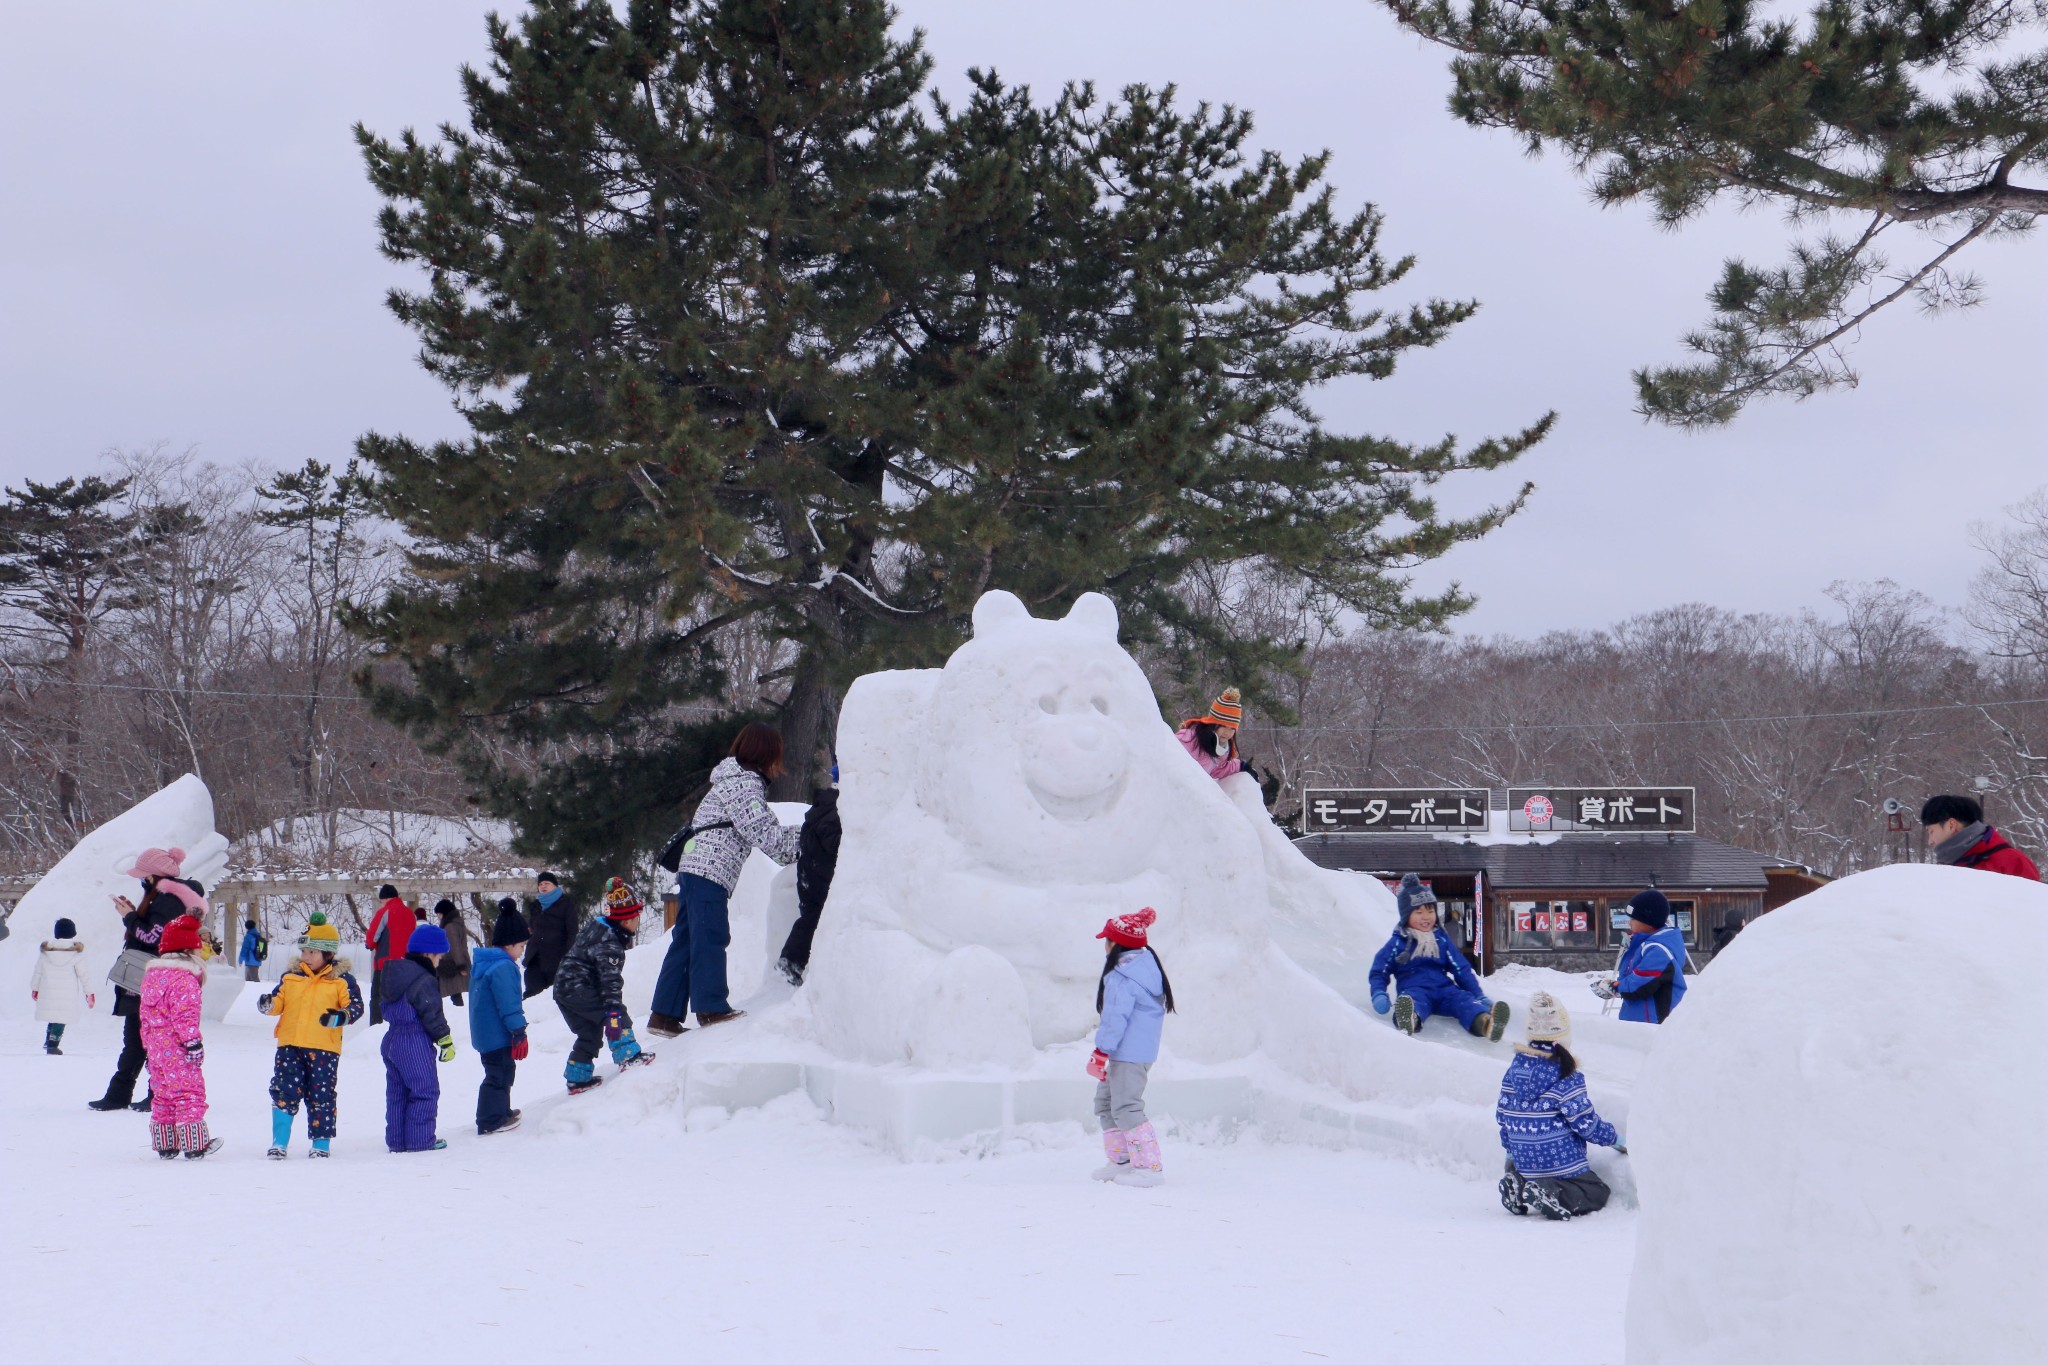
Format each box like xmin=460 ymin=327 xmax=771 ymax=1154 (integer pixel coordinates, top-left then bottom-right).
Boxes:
xmin=803 ymin=591 xmax=1405 ymax=1093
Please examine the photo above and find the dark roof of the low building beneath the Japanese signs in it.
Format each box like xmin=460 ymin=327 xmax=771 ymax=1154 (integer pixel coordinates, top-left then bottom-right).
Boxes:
xmin=1294 ymin=835 xmax=1778 ymax=892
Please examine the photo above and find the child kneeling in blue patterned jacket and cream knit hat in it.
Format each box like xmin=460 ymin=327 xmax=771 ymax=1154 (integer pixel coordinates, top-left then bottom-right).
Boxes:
xmin=1493 ymin=990 xmax=1628 ymax=1220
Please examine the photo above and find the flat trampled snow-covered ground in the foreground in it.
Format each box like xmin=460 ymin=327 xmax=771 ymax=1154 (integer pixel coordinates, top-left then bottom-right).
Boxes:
xmin=0 ymin=1001 xmax=1634 ymax=1365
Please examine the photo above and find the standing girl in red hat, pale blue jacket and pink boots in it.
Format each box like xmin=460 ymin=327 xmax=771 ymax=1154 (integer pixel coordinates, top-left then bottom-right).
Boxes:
xmin=1087 ymin=907 xmax=1174 ymax=1185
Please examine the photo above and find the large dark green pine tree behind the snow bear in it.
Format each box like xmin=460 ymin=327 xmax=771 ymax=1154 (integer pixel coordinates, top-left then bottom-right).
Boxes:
xmin=358 ymin=0 xmax=1548 ymax=866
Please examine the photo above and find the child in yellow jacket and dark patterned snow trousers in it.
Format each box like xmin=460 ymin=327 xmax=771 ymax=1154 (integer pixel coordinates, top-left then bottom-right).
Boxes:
xmin=256 ymin=911 xmax=362 ymax=1160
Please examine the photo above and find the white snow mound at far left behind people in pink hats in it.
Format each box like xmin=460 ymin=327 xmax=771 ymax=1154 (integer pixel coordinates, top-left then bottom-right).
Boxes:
xmin=0 ymin=774 xmax=227 ymax=1019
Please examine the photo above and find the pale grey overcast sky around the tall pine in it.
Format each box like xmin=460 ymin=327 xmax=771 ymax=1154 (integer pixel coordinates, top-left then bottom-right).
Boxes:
xmin=0 ymin=0 xmax=2048 ymax=634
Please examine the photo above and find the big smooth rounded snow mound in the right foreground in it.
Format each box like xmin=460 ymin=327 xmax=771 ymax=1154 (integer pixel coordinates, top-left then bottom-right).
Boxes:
xmin=1628 ymin=866 xmax=2048 ymax=1365
